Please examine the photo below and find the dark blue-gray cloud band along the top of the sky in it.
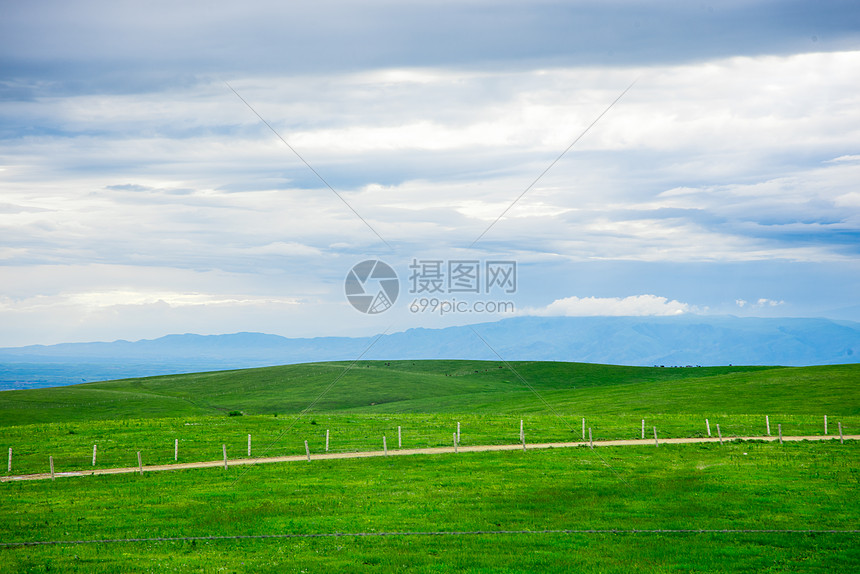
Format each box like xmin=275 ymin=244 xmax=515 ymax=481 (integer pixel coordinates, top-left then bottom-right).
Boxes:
xmin=0 ymin=0 xmax=860 ymax=98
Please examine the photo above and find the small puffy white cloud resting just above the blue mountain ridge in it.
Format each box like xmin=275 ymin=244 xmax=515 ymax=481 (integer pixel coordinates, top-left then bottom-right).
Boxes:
xmin=520 ymin=295 xmax=694 ymax=317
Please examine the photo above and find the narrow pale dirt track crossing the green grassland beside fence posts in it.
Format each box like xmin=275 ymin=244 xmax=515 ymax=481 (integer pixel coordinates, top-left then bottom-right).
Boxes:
xmin=5 ymin=434 xmax=860 ymax=482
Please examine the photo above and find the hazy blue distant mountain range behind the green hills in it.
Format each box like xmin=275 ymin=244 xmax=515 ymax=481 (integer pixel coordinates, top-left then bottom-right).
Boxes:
xmin=0 ymin=315 xmax=860 ymax=390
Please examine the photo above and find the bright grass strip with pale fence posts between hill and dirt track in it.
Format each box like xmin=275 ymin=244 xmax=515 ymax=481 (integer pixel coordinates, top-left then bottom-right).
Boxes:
xmin=7 ymin=415 xmax=860 ymax=482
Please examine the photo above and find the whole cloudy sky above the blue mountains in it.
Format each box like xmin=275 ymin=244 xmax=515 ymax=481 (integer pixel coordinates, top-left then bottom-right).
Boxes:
xmin=0 ymin=0 xmax=860 ymax=346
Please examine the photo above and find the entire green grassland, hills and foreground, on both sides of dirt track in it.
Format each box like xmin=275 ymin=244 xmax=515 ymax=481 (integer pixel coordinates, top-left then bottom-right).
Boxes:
xmin=0 ymin=361 xmax=860 ymax=572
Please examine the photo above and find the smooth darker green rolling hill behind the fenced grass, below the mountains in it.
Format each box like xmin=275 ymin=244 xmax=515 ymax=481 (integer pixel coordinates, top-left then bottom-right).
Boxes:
xmin=0 ymin=361 xmax=860 ymax=426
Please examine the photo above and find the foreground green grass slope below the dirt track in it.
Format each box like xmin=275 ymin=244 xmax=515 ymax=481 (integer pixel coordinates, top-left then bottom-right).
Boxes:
xmin=0 ymin=441 xmax=860 ymax=572
